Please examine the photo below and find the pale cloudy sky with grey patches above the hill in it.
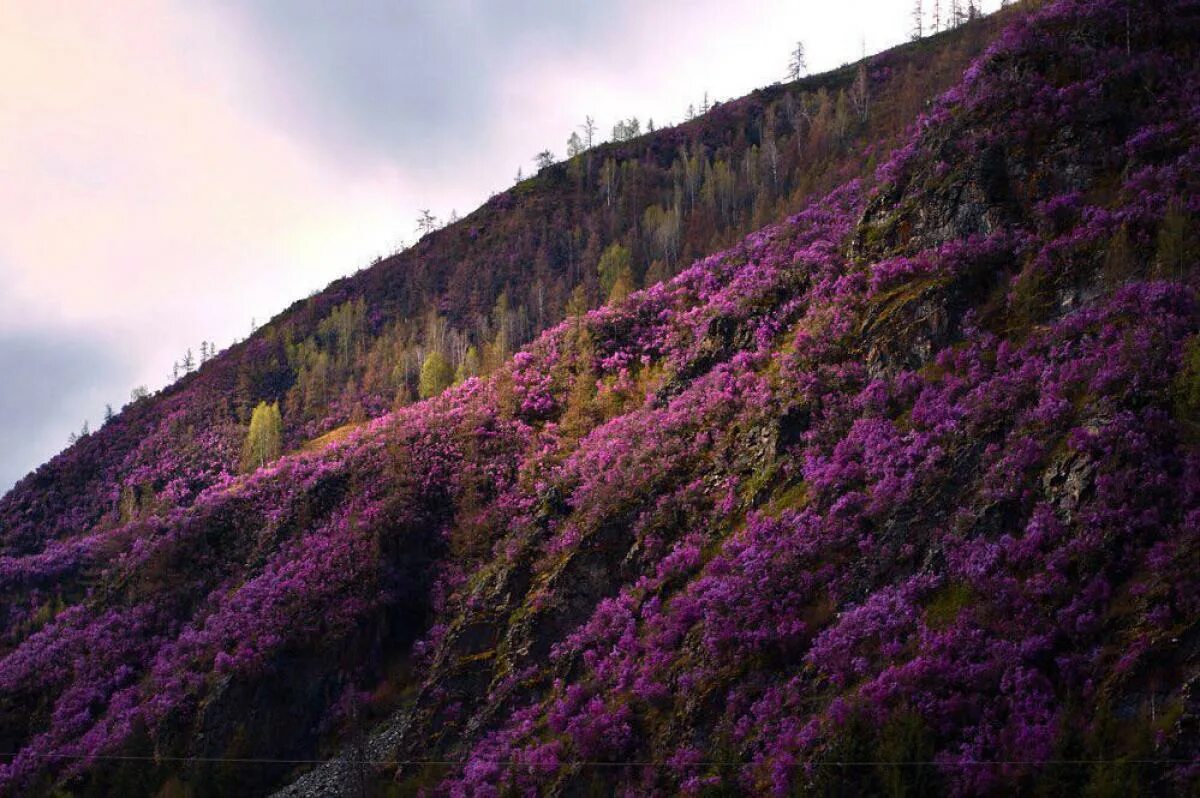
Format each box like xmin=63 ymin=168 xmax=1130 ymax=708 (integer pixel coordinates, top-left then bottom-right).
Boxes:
xmin=0 ymin=0 xmax=998 ymax=491
